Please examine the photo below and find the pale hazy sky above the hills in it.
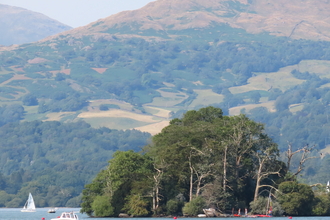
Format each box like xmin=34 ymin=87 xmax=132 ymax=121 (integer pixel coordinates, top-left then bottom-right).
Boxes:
xmin=0 ymin=0 xmax=155 ymax=28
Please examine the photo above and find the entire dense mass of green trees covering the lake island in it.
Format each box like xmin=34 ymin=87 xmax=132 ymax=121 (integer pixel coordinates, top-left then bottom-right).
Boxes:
xmin=81 ymin=107 xmax=285 ymax=216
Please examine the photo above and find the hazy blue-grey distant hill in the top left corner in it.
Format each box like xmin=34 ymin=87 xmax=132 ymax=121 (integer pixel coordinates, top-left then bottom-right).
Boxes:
xmin=0 ymin=4 xmax=72 ymax=46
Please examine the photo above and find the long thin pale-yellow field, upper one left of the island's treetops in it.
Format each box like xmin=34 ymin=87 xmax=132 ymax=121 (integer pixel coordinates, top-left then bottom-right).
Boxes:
xmin=78 ymin=109 xmax=159 ymax=123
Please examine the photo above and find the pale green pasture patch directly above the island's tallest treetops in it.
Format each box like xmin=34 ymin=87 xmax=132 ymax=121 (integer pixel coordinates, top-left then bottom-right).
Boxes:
xmin=189 ymin=89 xmax=224 ymax=108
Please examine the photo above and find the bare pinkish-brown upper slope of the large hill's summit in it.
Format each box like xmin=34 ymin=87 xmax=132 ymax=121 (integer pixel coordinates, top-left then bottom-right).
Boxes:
xmin=59 ymin=0 xmax=330 ymax=41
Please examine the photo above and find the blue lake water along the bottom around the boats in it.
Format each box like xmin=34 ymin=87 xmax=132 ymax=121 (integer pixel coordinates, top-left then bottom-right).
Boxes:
xmin=0 ymin=208 xmax=330 ymax=220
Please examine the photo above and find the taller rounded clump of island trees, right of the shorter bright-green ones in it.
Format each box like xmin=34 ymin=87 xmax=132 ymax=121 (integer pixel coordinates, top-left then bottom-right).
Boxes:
xmin=148 ymin=107 xmax=280 ymax=213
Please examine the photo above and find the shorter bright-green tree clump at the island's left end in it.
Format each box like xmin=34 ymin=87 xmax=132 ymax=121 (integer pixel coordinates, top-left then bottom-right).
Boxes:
xmin=81 ymin=151 xmax=154 ymax=217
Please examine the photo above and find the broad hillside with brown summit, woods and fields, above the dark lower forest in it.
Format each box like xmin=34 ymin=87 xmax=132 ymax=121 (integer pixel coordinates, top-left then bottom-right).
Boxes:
xmin=0 ymin=0 xmax=330 ymax=153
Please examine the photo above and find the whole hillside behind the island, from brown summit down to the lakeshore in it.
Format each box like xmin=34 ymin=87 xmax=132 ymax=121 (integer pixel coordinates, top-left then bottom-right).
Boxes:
xmin=0 ymin=0 xmax=330 ymax=207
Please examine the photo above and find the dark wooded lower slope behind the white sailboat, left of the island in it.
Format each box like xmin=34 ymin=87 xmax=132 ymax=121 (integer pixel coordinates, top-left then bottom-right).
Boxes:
xmin=0 ymin=121 xmax=150 ymax=207
